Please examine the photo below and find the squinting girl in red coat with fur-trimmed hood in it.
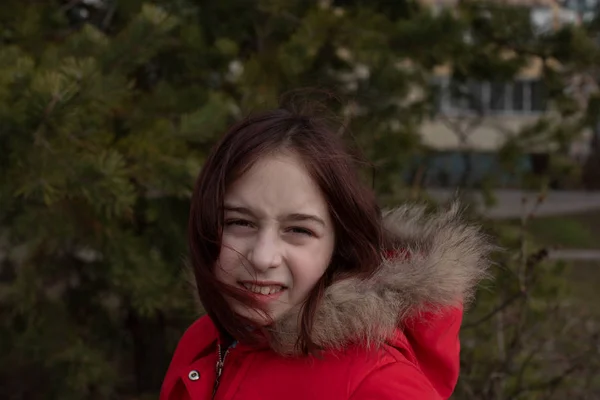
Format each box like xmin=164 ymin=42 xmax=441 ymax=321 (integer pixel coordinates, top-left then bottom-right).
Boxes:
xmin=160 ymin=109 xmax=491 ymax=400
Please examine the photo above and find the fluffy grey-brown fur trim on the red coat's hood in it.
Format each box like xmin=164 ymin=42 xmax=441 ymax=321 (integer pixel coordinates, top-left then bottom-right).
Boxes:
xmin=270 ymin=203 xmax=495 ymax=355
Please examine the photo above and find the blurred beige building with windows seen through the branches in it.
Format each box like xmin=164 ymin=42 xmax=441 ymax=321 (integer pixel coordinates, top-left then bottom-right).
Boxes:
xmin=418 ymin=0 xmax=597 ymax=187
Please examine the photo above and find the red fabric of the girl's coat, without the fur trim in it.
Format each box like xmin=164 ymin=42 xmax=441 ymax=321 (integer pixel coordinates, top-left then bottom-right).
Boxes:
xmin=160 ymin=309 xmax=462 ymax=400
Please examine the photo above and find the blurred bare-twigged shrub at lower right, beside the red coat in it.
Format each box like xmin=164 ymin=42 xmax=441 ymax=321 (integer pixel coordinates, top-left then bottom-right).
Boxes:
xmin=453 ymin=212 xmax=600 ymax=399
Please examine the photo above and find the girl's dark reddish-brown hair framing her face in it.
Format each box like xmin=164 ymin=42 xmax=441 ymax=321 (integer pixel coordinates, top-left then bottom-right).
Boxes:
xmin=188 ymin=108 xmax=382 ymax=354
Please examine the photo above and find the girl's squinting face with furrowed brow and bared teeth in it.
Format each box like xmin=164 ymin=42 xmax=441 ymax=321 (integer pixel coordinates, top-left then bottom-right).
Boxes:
xmin=215 ymin=153 xmax=335 ymax=324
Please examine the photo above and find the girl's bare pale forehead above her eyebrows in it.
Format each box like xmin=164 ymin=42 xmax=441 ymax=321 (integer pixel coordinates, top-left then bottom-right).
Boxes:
xmin=225 ymin=153 xmax=327 ymax=216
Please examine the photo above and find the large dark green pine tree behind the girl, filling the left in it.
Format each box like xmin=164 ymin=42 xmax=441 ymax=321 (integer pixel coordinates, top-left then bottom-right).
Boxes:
xmin=0 ymin=0 xmax=434 ymax=399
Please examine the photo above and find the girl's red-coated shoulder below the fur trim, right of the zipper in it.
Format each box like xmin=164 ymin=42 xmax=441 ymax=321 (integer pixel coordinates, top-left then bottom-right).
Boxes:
xmin=350 ymin=346 xmax=442 ymax=400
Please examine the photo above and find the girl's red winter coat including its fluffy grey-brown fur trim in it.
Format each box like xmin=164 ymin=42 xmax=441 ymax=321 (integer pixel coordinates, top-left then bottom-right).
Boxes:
xmin=160 ymin=205 xmax=489 ymax=400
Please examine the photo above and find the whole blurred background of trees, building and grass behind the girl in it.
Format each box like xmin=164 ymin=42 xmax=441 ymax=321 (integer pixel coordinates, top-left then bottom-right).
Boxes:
xmin=0 ymin=0 xmax=600 ymax=400
